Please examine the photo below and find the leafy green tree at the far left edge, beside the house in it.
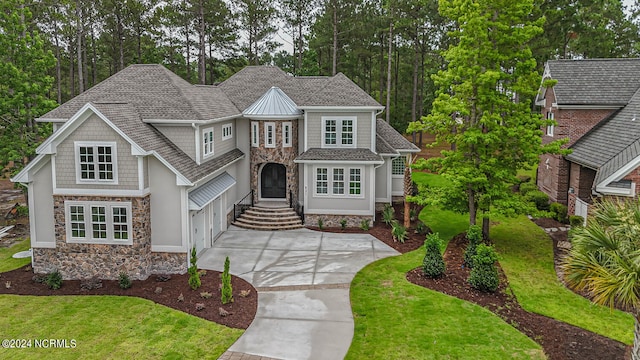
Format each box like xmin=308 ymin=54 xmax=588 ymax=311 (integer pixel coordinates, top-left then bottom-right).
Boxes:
xmin=0 ymin=0 xmax=55 ymax=174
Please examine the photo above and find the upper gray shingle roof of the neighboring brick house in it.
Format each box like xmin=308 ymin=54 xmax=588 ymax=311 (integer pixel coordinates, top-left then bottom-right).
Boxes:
xmin=547 ymin=59 xmax=640 ymax=105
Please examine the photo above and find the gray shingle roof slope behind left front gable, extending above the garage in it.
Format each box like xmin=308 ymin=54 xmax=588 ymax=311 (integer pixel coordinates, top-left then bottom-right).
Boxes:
xmin=87 ymin=103 xmax=244 ymax=182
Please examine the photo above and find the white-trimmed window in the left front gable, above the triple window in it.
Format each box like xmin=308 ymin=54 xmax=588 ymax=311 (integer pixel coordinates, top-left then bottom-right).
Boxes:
xmin=74 ymin=142 xmax=118 ymax=184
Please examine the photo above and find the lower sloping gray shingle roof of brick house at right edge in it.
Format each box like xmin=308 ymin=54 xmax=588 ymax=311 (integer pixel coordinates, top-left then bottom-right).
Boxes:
xmin=566 ymin=88 xmax=640 ymax=184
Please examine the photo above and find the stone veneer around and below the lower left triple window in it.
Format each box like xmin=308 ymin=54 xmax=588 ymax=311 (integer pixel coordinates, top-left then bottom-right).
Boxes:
xmin=33 ymin=196 xmax=187 ymax=280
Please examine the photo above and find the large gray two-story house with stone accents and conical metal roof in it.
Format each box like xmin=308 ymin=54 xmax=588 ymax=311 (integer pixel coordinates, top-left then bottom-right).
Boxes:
xmin=12 ymin=65 xmax=418 ymax=279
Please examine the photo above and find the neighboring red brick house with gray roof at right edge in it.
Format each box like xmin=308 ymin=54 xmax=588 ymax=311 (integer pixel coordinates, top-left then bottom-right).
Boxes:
xmin=536 ymin=59 xmax=640 ymax=222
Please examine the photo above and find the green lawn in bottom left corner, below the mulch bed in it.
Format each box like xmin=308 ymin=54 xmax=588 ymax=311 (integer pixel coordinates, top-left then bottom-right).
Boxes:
xmin=0 ymin=295 xmax=243 ymax=359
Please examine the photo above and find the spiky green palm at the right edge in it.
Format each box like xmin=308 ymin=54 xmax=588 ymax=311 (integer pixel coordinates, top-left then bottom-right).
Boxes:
xmin=562 ymin=200 xmax=640 ymax=360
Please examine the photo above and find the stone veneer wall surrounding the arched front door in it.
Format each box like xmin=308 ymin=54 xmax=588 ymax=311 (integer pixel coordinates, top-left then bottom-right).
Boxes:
xmin=250 ymin=119 xmax=299 ymax=204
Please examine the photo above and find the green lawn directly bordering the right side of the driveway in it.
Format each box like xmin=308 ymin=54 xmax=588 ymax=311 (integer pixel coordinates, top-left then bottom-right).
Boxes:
xmin=346 ymin=248 xmax=544 ymax=359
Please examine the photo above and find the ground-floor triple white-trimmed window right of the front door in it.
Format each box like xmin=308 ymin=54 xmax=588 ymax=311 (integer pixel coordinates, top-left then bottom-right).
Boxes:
xmin=314 ymin=167 xmax=364 ymax=198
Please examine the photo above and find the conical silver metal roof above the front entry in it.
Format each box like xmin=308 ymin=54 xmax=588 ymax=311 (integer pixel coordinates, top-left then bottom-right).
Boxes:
xmin=242 ymin=86 xmax=302 ymax=119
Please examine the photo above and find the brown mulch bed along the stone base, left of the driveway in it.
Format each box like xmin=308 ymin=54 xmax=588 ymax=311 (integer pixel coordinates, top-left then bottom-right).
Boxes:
xmin=0 ymin=265 xmax=258 ymax=329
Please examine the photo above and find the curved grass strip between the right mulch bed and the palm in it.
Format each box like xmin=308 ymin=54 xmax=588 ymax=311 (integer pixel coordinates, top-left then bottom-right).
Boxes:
xmin=491 ymin=216 xmax=634 ymax=344
